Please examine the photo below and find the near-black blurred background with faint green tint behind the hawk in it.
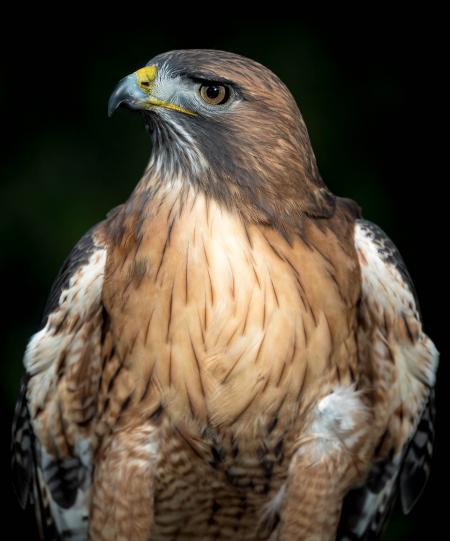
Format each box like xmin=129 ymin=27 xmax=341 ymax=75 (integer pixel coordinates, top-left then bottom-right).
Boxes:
xmin=0 ymin=14 xmax=449 ymax=541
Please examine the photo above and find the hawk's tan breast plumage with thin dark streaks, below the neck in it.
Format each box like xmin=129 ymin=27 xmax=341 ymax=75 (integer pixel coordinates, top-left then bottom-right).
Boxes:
xmin=104 ymin=189 xmax=357 ymax=433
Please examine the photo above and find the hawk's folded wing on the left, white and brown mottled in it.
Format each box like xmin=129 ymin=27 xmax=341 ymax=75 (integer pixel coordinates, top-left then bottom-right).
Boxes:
xmin=12 ymin=224 xmax=107 ymax=541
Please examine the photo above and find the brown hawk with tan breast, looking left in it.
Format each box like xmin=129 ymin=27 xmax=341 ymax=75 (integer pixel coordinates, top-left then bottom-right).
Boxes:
xmin=13 ymin=50 xmax=438 ymax=541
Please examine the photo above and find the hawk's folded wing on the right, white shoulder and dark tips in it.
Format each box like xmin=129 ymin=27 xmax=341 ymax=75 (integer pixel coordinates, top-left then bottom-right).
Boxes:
xmin=337 ymin=220 xmax=439 ymax=541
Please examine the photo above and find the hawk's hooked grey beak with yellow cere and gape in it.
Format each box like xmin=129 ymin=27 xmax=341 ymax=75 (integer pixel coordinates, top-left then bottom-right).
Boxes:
xmin=108 ymin=66 xmax=195 ymax=117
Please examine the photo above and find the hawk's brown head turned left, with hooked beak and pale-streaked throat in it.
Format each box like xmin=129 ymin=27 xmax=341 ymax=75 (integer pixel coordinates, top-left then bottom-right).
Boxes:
xmin=108 ymin=49 xmax=334 ymax=224
